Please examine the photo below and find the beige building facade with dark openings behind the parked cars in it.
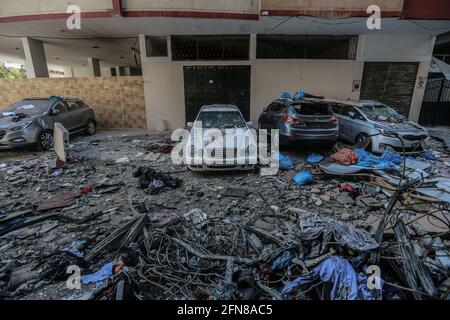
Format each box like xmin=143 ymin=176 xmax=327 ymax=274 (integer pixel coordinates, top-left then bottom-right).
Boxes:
xmin=0 ymin=0 xmax=450 ymax=130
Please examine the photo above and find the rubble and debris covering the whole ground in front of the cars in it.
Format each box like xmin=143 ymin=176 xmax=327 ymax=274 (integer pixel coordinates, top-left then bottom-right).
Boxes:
xmin=0 ymin=131 xmax=450 ymax=300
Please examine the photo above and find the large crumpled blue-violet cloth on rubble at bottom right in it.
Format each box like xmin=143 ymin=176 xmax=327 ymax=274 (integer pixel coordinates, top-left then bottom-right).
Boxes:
xmin=282 ymin=256 xmax=381 ymax=300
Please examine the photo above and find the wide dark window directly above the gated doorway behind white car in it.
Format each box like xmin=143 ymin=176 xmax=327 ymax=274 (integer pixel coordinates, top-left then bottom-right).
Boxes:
xmin=171 ymin=35 xmax=250 ymax=61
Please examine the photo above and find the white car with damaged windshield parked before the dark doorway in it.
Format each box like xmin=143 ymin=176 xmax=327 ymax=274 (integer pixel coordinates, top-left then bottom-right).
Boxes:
xmin=185 ymin=105 xmax=258 ymax=171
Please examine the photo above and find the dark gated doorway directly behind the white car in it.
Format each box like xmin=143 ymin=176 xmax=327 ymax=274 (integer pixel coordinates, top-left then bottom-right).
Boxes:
xmin=184 ymin=66 xmax=251 ymax=122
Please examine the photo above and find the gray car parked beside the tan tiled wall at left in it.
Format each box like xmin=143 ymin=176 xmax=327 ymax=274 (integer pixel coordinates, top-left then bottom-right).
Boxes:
xmin=0 ymin=97 xmax=96 ymax=150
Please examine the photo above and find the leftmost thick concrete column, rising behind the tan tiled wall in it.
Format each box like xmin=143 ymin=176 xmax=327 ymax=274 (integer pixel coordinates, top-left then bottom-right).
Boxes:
xmin=22 ymin=37 xmax=49 ymax=78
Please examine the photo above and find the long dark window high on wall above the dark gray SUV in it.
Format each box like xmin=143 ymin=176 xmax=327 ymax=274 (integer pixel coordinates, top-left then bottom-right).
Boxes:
xmin=256 ymin=35 xmax=358 ymax=60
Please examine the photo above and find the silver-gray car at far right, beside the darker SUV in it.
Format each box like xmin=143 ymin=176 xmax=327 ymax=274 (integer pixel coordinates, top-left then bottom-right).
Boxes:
xmin=327 ymin=100 xmax=429 ymax=153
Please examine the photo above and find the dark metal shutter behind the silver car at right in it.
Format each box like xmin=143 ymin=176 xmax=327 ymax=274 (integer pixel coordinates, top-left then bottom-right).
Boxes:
xmin=361 ymin=62 xmax=419 ymax=116
